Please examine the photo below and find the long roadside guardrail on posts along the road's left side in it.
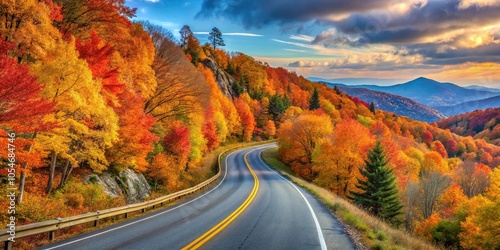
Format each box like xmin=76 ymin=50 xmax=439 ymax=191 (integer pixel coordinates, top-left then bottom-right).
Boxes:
xmin=0 ymin=141 xmax=274 ymax=250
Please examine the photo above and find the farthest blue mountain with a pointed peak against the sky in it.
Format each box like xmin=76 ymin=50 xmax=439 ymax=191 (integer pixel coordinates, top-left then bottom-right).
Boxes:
xmin=318 ymin=77 xmax=498 ymax=107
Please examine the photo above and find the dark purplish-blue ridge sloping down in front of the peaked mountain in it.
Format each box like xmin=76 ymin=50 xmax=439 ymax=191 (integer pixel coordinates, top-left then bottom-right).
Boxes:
xmin=328 ymin=85 xmax=445 ymax=123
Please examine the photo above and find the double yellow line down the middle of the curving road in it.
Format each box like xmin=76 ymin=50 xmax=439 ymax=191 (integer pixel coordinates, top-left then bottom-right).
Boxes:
xmin=182 ymin=150 xmax=259 ymax=250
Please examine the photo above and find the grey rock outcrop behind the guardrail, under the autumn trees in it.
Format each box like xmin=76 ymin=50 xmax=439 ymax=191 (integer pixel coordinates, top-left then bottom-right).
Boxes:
xmin=85 ymin=169 xmax=151 ymax=204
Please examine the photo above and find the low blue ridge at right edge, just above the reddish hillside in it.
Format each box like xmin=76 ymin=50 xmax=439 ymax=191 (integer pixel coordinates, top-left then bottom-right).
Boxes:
xmin=436 ymin=93 xmax=500 ymax=116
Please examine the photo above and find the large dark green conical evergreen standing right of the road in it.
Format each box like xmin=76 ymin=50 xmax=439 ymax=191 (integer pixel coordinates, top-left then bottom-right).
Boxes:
xmin=350 ymin=141 xmax=403 ymax=223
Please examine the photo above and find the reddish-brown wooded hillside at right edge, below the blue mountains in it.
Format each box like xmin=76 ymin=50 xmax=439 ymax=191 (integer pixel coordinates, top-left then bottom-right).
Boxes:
xmin=437 ymin=108 xmax=500 ymax=146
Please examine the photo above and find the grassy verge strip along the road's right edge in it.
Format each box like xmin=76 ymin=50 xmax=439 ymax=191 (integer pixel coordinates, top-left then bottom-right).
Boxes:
xmin=262 ymin=148 xmax=439 ymax=249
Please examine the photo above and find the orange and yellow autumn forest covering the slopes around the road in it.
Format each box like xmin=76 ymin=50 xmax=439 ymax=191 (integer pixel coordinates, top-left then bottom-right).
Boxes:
xmin=0 ymin=0 xmax=500 ymax=249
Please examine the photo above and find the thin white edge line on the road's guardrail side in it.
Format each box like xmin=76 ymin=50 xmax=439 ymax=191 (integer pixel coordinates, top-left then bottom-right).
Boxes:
xmin=40 ymin=145 xmax=276 ymax=250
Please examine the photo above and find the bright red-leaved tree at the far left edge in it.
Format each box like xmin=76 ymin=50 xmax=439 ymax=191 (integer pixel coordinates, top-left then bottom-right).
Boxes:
xmin=0 ymin=41 xmax=56 ymax=203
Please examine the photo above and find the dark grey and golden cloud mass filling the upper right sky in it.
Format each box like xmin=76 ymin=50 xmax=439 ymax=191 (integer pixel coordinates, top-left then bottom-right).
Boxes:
xmin=197 ymin=0 xmax=500 ymax=83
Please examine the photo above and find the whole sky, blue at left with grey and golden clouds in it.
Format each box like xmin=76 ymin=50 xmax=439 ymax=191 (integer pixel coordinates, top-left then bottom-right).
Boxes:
xmin=126 ymin=0 xmax=500 ymax=88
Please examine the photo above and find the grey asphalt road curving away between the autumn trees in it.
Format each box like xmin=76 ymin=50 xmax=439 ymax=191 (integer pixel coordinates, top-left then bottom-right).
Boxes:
xmin=40 ymin=144 xmax=354 ymax=250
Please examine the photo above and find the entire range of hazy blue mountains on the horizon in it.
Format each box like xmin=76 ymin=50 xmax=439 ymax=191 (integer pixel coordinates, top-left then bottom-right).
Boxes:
xmin=310 ymin=77 xmax=500 ymax=119
